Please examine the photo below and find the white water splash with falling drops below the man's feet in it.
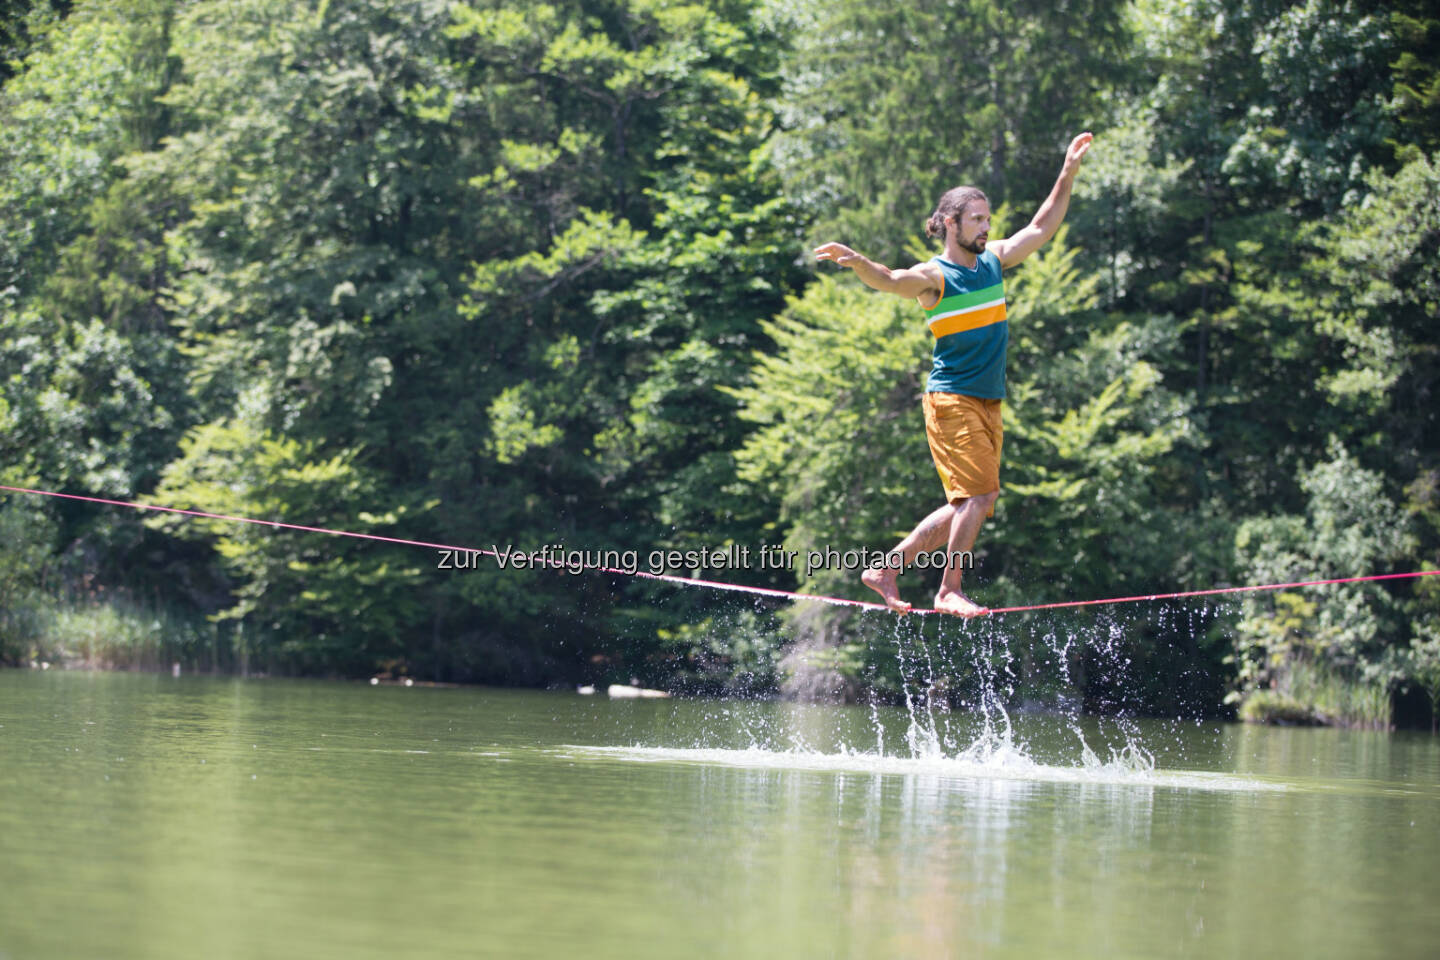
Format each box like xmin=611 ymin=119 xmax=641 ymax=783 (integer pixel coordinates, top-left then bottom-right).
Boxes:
xmin=578 ymin=592 xmax=1232 ymax=783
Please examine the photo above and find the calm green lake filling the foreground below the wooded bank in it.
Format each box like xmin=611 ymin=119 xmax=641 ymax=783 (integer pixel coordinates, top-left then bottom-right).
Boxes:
xmin=0 ymin=671 xmax=1440 ymax=960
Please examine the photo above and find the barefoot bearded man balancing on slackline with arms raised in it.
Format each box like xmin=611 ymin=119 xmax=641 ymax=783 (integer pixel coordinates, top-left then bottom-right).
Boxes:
xmin=815 ymin=132 xmax=1092 ymax=617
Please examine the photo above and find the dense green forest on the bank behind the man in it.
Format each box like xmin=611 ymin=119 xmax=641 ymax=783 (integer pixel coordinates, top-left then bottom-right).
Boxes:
xmin=0 ymin=0 xmax=1440 ymax=727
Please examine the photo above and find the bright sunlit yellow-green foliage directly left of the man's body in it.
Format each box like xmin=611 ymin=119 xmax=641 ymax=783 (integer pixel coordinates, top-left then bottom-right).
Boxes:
xmin=734 ymin=278 xmax=940 ymax=590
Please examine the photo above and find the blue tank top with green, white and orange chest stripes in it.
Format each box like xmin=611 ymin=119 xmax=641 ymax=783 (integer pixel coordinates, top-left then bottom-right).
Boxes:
xmin=924 ymin=250 xmax=1009 ymax=400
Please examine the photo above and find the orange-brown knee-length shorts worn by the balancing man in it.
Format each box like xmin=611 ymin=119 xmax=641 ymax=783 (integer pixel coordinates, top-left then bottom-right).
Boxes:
xmin=924 ymin=393 xmax=1005 ymax=514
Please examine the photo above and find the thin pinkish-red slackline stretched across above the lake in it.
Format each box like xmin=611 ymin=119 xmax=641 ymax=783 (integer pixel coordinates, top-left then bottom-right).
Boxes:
xmin=0 ymin=484 xmax=1440 ymax=615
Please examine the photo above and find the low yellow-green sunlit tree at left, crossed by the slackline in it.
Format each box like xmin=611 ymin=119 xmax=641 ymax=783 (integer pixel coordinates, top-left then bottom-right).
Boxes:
xmin=147 ymin=420 xmax=425 ymax=675
